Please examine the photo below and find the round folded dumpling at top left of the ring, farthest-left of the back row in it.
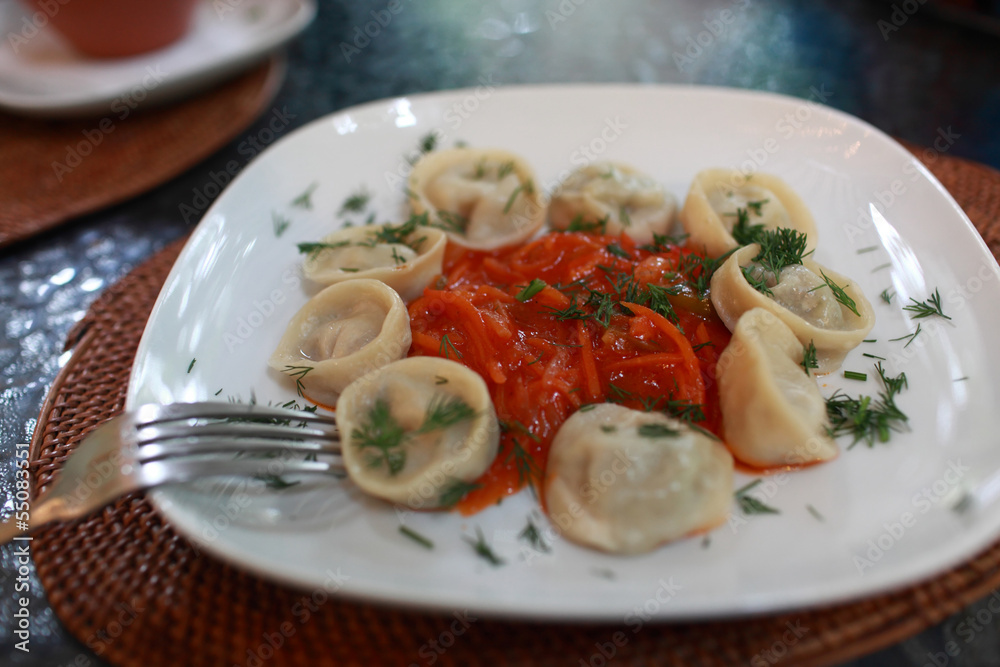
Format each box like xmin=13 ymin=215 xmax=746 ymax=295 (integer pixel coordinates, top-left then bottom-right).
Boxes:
xmin=409 ymin=148 xmax=545 ymax=250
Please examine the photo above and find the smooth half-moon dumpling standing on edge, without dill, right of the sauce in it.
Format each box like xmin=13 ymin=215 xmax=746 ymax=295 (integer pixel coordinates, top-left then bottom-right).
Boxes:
xmin=716 ymin=308 xmax=838 ymax=468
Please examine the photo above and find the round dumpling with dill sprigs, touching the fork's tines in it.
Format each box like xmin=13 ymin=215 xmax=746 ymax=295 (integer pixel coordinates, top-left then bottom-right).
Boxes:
xmin=337 ymin=357 xmax=500 ymax=509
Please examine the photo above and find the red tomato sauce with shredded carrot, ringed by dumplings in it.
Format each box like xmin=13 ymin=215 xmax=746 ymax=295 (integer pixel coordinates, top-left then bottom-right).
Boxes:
xmin=409 ymin=232 xmax=730 ymax=515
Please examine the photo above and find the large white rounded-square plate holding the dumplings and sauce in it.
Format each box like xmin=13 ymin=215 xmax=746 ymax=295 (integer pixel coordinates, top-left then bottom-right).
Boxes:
xmin=128 ymin=86 xmax=1000 ymax=624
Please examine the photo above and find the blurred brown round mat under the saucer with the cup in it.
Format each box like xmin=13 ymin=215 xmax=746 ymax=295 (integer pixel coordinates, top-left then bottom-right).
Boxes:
xmin=0 ymin=59 xmax=285 ymax=247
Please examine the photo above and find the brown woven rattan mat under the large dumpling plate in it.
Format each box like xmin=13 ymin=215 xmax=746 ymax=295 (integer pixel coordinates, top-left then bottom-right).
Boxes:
xmin=32 ymin=146 xmax=1000 ymax=667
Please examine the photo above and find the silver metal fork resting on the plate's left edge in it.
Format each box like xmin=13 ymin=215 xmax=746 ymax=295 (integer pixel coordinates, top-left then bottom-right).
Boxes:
xmin=0 ymin=403 xmax=345 ymax=545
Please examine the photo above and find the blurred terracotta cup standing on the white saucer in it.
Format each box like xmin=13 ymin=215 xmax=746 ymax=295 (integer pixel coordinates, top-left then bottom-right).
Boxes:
xmin=27 ymin=0 xmax=199 ymax=58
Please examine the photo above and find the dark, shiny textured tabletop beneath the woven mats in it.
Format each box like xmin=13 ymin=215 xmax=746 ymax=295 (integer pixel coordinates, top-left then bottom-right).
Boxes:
xmin=0 ymin=0 xmax=1000 ymax=667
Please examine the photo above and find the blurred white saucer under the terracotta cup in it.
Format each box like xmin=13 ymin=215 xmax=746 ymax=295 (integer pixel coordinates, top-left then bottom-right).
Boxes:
xmin=0 ymin=0 xmax=316 ymax=117
